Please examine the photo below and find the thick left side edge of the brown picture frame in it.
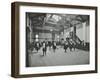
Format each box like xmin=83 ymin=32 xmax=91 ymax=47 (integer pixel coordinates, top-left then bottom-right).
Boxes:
xmin=11 ymin=3 xmax=19 ymax=77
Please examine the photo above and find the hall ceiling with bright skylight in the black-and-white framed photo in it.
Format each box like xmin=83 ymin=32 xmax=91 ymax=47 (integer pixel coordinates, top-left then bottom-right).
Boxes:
xmin=27 ymin=13 xmax=89 ymax=32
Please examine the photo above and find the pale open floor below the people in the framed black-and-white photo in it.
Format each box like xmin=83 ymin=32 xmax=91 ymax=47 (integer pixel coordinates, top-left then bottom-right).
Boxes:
xmin=29 ymin=47 xmax=89 ymax=67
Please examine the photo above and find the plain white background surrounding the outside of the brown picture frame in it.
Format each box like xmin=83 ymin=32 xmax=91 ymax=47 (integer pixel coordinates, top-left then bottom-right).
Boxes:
xmin=0 ymin=0 xmax=100 ymax=80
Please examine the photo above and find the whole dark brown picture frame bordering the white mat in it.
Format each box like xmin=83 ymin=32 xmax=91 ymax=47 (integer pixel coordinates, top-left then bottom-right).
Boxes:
xmin=11 ymin=2 xmax=98 ymax=78
